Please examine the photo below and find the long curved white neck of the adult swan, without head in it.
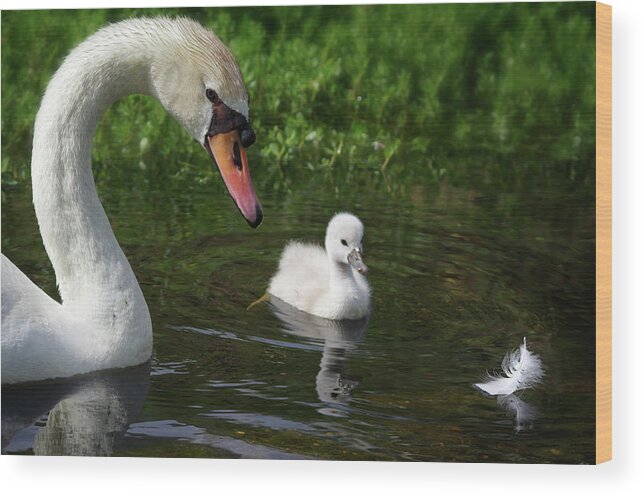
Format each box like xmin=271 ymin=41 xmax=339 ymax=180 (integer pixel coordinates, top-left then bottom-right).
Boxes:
xmin=31 ymin=32 xmax=152 ymax=332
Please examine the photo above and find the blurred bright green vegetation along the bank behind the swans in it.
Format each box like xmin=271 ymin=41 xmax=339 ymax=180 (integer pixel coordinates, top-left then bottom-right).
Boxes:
xmin=2 ymin=2 xmax=595 ymax=197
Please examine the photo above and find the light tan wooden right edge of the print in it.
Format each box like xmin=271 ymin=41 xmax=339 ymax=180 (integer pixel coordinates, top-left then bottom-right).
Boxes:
xmin=596 ymin=2 xmax=612 ymax=463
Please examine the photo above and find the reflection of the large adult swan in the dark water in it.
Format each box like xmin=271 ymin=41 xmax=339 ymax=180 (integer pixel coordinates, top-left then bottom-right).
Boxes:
xmin=2 ymin=364 xmax=150 ymax=456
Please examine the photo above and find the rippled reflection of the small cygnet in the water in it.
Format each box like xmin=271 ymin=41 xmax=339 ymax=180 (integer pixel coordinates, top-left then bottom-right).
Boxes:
xmin=269 ymin=296 xmax=368 ymax=416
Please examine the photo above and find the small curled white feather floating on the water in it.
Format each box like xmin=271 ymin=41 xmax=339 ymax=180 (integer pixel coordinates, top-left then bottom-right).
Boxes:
xmin=475 ymin=338 xmax=545 ymax=396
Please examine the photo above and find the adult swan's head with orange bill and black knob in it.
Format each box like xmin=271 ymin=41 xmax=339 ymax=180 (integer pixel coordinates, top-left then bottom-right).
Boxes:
xmin=151 ymin=18 xmax=263 ymax=227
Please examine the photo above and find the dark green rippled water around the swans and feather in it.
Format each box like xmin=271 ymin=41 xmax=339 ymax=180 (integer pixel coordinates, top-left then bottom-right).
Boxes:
xmin=2 ymin=164 xmax=595 ymax=463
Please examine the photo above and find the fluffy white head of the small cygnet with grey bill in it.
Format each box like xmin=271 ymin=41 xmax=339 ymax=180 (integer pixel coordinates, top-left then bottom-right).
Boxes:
xmin=325 ymin=213 xmax=368 ymax=274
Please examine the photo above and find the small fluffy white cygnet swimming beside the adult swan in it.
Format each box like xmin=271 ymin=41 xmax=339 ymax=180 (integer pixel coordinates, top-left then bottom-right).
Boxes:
xmin=267 ymin=213 xmax=370 ymax=320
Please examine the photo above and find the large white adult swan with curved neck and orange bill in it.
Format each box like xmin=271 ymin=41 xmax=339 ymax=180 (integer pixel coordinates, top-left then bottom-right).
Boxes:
xmin=2 ymin=18 xmax=262 ymax=383
